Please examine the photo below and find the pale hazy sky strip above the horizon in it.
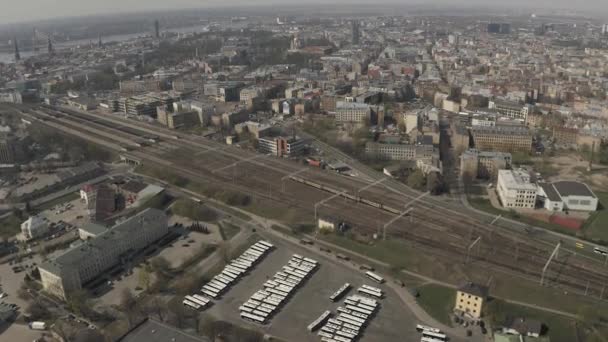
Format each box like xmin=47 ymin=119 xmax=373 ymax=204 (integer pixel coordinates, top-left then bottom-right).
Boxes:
xmin=0 ymin=0 xmax=608 ymax=23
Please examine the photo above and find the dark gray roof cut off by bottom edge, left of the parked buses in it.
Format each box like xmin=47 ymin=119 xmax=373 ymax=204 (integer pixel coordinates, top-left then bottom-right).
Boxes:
xmin=118 ymin=319 xmax=210 ymax=342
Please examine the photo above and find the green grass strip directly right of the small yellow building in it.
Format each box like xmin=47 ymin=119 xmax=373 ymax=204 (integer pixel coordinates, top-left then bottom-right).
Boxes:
xmin=484 ymin=299 xmax=578 ymax=342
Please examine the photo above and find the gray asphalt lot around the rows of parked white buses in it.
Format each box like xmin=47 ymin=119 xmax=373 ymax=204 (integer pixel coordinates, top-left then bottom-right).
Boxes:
xmin=201 ymin=236 xmax=420 ymax=342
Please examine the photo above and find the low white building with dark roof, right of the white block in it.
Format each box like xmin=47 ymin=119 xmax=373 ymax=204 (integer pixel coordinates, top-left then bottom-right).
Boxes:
xmin=538 ymin=181 xmax=599 ymax=211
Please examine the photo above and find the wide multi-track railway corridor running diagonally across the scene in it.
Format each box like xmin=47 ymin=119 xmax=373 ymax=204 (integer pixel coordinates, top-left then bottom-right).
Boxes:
xmin=16 ymin=108 xmax=608 ymax=300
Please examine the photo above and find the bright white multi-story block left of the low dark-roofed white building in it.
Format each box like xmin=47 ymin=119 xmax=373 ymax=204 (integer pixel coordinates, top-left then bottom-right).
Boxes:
xmin=496 ymin=170 xmax=538 ymax=209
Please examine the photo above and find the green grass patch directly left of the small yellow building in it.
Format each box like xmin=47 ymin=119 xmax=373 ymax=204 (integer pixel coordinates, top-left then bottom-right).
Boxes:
xmin=416 ymin=284 xmax=456 ymax=326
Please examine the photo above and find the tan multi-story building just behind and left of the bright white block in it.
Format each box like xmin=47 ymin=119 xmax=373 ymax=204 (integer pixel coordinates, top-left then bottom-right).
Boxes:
xmin=460 ymin=149 xmax=512 ymax=179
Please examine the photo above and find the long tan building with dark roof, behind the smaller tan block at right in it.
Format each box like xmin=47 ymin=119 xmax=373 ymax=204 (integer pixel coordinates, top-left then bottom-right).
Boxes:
xmin=471 ymin=125 xmax=532 ymax=152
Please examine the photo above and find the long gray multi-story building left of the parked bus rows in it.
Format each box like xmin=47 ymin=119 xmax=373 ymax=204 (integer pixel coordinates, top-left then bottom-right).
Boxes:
xmin=39 ymin=208 xmax=169 ymax=299
